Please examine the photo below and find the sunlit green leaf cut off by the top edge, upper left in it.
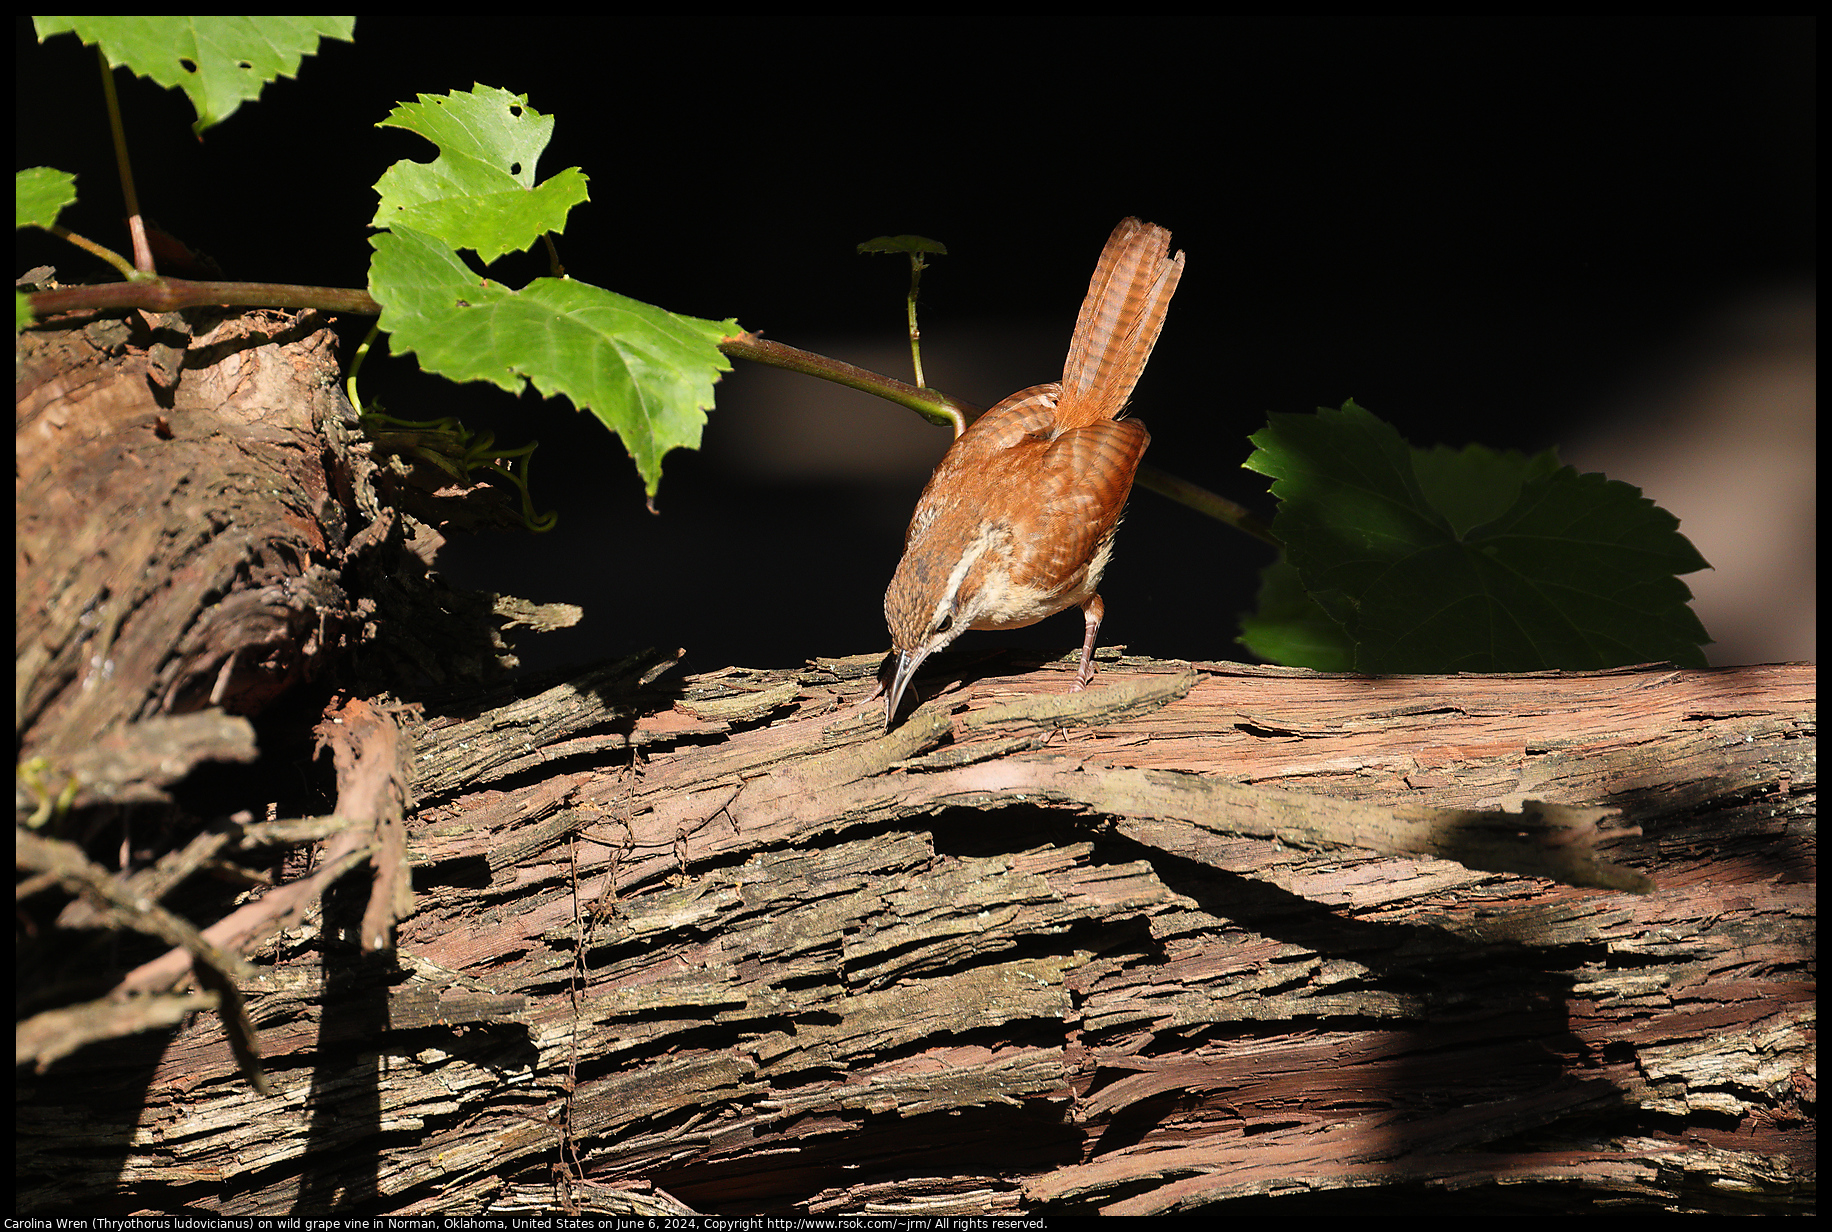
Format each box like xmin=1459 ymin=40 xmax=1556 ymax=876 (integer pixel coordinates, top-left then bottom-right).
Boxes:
xmin=31 ymin=17 xmax=355 ymax=136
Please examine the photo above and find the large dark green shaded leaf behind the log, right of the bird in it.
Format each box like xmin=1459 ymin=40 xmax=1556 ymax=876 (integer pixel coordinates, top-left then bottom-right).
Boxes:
xmin=1246 ymin=403 xmax=1709 ymax=673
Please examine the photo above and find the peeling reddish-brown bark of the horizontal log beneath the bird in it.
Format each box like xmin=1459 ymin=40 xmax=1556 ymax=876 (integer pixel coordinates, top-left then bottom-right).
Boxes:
xmin=14 ymin=658 xmax=1814 ymax=1214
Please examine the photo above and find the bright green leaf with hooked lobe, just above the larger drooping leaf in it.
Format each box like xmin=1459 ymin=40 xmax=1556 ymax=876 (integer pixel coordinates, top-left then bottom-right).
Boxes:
xmin=370 ymin=86 xmax=586 ymax=262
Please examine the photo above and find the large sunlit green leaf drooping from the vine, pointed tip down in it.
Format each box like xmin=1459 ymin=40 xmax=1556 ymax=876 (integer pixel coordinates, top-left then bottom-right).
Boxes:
xmin=368 ymin=226 xmax=740 ymax=497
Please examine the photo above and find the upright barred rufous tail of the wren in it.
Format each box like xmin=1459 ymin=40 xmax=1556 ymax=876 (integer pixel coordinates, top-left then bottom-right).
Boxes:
xmin=1055 ymin=218 xmax=1183 ymax=431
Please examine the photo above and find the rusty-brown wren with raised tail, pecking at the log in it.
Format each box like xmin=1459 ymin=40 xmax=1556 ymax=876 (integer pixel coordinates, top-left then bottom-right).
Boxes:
xmin=885 ymin=218 xmax=1183 ymax=730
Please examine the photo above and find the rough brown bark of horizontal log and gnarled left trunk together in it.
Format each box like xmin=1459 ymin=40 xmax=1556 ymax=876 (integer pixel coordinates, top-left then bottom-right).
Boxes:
xmin=16 ymin=306 xmax=1816 ymax=1214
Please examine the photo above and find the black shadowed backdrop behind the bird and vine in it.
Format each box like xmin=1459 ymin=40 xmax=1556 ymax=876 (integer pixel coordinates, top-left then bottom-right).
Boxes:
xmin=16 ymin=17 xmax=1816 ymax=671
